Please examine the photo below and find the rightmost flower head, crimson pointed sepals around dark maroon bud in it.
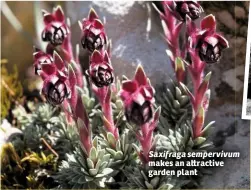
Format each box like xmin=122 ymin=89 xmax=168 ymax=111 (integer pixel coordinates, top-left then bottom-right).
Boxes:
xmin=190 ymin=15 xmax=228 ymax=64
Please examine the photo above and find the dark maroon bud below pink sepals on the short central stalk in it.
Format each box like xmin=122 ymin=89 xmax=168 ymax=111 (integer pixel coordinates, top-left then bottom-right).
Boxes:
xmin=125 ymin=101 xmax=153 ymax=126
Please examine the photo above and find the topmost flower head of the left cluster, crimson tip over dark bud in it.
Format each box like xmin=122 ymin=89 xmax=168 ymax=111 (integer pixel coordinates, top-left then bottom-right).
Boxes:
xmin=42 ymin=6 xmax=69 ymax=46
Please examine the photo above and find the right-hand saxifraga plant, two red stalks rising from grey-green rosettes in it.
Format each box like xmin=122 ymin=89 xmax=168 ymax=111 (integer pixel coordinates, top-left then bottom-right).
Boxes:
xmin=153 ymin=1 xmax=228 ymax=187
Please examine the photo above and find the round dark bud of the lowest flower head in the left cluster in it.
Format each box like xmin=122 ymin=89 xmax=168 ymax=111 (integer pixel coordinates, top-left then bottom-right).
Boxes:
xmin=42 ymin=77 xmax=70 ymax=106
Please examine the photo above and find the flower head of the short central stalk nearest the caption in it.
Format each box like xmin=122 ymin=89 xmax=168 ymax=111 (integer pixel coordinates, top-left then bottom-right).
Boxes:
xmin=120 ymin=66 xmax=155 ymax=125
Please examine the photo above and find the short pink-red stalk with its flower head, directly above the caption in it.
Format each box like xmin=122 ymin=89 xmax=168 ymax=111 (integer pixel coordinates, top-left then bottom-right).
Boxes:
xmin=119 ymin=65 xmax=160 ymax=164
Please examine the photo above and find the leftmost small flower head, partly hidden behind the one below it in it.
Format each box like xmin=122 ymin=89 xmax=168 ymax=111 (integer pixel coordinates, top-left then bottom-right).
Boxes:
xmin=33 ymin=49 xmax=53 ymax=75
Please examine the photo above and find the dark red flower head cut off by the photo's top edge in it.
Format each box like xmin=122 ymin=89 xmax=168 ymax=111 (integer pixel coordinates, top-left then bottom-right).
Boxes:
xmin=164 ymin=0 xmax=203 ymax=21
